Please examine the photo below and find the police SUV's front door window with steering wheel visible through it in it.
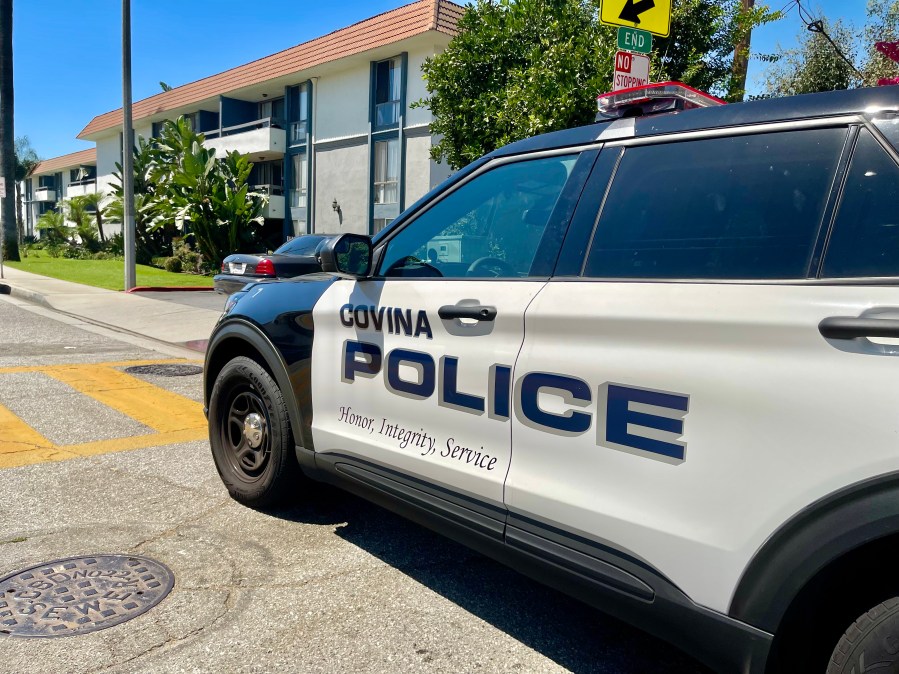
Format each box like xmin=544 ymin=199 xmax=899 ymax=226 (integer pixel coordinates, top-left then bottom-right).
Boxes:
xmin=380 ymin=155 xmax=577 ymax=278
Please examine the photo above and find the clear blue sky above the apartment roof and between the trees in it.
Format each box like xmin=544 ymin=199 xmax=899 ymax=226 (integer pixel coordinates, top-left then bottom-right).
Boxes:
xmin=13 ymin=0 xmax=866 ymax=159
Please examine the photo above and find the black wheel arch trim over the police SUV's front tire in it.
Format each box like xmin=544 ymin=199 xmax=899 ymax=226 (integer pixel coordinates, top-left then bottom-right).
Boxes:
xmin=203 ymin=319 xmax=311 ymax=449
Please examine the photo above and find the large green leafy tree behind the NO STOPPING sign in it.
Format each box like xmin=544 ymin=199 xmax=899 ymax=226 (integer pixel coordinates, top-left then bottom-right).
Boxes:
xmin=414 ymin=0 xmax=776 ymax=168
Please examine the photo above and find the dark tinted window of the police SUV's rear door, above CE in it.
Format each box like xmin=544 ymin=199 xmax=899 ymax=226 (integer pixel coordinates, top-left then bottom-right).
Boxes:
xmin=584 ymin=129 xmax=847 ymax=279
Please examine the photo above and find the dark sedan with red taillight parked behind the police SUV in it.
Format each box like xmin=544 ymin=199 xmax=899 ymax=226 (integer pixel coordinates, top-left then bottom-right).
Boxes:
xmin=213 ymin=234 xmax=334 ymax=295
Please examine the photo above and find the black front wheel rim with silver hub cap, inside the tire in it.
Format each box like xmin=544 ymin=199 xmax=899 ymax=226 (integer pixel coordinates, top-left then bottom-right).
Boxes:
xmin=221 ymin=387 xmax=272 ymax=480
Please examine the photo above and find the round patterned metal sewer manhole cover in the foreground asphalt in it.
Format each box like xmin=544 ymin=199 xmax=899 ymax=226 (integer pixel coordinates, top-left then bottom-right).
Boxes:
xmin=0 ymin=555 xmax=175 ymax=637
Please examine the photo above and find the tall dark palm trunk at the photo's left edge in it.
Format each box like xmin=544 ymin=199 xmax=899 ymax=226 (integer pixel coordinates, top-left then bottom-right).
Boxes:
xmin=0 ymin=0 xmax=19 ymax=260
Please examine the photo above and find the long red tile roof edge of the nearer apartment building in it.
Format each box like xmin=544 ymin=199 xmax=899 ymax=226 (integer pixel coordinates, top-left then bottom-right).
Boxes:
xmin=78 ymin=0 xmax=465 ymax=138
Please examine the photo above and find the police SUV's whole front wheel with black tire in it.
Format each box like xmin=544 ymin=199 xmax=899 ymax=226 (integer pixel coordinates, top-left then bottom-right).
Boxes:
xmin=209 ymin=356 xmax=302 ymax=508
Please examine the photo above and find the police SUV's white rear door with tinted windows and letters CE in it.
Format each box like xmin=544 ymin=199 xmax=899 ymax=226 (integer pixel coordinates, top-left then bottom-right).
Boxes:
xmin=506 ymin=120 xmax=899 ymax=611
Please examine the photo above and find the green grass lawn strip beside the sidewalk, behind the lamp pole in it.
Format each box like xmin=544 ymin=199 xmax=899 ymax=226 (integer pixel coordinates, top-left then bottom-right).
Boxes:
xmin=4 ymin=251 xmax=212 ymax=290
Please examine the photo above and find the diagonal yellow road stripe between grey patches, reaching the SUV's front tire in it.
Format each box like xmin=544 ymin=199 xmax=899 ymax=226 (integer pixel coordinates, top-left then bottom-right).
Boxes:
xmin=44 ymin=365 xmax=206 ymax=433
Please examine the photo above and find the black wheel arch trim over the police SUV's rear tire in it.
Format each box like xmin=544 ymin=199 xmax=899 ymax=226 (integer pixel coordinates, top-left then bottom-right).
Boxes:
xmin=728 ymin=472 xmax=899 ymax=634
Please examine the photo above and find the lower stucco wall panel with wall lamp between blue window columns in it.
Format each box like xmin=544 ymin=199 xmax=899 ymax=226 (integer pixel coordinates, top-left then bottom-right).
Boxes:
xmin=315 ymin=144 xmax=368 ymax=234
